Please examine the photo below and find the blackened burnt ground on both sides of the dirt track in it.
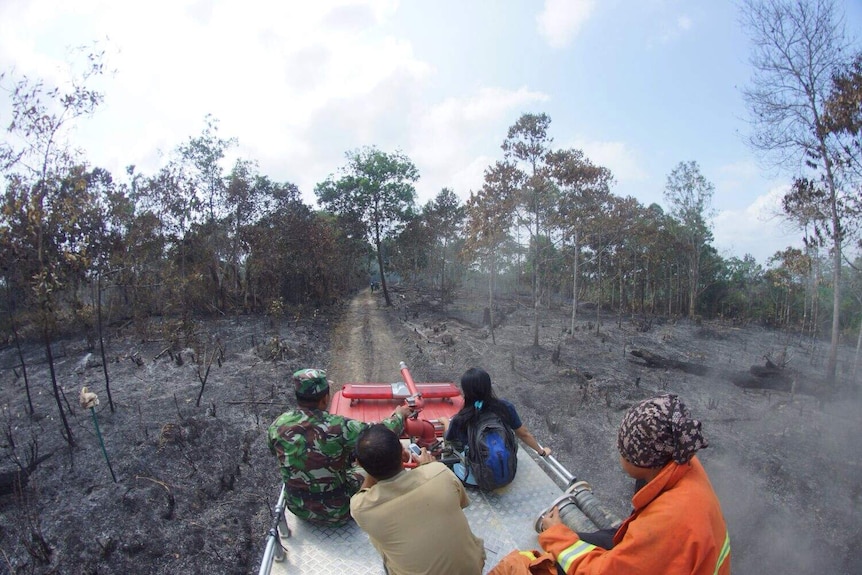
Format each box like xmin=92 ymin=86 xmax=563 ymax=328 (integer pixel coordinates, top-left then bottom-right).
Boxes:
xmin=0 ymin=287 xmax=862 ymax=575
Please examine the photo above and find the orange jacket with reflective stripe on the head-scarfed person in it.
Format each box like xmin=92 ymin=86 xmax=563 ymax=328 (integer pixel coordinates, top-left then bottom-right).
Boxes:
xmin=539 ymin=457 xmax=730 ymax=575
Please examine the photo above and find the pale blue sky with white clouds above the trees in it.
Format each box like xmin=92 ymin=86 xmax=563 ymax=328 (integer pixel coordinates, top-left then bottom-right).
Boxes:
xmin=0 ymin=0 xmax=862 ymax=264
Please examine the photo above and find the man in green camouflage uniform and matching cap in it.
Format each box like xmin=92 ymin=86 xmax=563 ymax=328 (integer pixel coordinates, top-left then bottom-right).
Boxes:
xmin=267 ymin=369 xmax=410 ymax=525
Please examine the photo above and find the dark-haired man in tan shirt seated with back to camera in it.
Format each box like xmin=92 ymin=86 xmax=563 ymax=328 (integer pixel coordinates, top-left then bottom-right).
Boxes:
xmin=350 ymin=424 xmax=485 ymax=575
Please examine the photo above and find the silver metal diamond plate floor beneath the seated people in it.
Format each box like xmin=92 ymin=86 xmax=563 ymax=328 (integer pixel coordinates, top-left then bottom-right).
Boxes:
xmin=271 ymin=446 xmax=562 ymax=575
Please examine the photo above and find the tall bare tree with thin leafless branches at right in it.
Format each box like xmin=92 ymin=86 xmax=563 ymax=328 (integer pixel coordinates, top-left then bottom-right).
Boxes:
xmin=742 ymin=0 xmax=848 ymax=388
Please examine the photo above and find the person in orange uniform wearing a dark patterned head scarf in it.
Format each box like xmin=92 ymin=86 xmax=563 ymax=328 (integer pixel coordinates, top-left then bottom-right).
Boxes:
xmin=491 ymin=394 xmax=730 ymax=575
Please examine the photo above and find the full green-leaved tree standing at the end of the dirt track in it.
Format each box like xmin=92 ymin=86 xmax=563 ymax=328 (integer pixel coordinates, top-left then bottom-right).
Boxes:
xmin=314 ymin=147 xmax=419 ymax=306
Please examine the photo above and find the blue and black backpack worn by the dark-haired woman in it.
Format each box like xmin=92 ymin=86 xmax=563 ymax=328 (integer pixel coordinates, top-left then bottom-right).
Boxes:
xmin=465 ymin=410 xmax=518 ymax=491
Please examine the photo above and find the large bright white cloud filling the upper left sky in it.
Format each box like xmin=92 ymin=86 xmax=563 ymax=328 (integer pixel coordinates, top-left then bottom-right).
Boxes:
xmin=0 ymin=0 xmax=433 ymax=201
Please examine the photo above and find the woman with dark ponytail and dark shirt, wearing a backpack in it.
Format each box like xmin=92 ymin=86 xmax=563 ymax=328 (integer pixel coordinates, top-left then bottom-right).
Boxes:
xmin=440 ymin=367 xmax=551 ymax=485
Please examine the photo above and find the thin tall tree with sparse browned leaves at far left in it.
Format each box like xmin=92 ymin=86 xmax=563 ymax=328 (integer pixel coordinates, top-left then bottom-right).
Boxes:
xmin=0 ymin=54 xmax=102 ymax=446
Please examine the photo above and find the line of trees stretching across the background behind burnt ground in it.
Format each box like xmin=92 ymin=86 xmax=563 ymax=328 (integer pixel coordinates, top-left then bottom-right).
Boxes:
xmin=0 ymin=6 xmax=862 ymax=437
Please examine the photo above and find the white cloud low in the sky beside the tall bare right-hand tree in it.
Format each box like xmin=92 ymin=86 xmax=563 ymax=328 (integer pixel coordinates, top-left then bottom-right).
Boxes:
xmin=713 ymin=185 xmax=802 ymax=264
